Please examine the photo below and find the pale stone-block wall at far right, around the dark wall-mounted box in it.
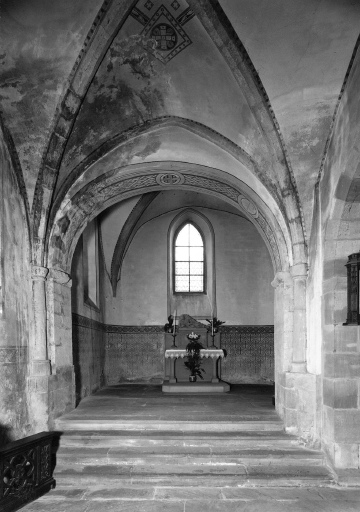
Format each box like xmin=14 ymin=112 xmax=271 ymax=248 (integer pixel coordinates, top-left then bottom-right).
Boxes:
xmin=316 ymin=48 xmax=360 ymax=468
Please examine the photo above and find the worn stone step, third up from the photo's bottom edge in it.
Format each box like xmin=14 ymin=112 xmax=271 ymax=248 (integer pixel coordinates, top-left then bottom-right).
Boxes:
xmin=57 ymin=445 xmax=324 ymax=467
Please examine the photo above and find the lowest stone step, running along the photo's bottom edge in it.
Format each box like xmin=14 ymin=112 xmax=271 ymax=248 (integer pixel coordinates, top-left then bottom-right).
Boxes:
xmin=22 ymin=494 xmax=359 ymax=512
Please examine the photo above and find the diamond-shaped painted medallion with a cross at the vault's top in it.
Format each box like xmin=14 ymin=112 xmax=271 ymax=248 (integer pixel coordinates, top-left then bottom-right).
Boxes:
xmin=142 ymin=5 xmax=192 ymax=64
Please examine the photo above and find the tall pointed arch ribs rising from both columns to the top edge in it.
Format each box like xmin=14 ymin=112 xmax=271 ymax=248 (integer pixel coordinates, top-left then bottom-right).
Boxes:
xmin=32 ymin=0 xmax=307 ymax=274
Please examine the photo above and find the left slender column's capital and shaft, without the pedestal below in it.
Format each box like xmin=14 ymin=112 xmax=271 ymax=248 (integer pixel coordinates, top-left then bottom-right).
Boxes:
xmin=30 ymin=265 xmax=50 ymax=375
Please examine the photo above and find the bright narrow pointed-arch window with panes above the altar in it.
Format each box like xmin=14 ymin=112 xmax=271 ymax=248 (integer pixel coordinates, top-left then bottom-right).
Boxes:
xmin=174 ymin=222 xmax=205 ymax=293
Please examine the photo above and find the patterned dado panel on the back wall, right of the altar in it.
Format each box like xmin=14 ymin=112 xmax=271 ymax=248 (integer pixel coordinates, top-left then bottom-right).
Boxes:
xmin=220 ymin=325 xmax=274 ymax=384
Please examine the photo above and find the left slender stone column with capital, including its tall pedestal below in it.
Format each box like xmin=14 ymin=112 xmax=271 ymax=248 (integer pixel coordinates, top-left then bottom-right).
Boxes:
xmin=28 ymin=265 xmax=51 ymax=433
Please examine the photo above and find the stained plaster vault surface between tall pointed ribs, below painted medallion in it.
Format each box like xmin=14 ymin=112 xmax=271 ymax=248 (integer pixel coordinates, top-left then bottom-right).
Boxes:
xmin=58 ymin=10 xmax=267 ymax=186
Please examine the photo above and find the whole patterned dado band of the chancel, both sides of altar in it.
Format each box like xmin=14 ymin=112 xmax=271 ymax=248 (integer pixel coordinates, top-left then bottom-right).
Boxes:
xmin=73 ymin=315 xmax=274 ymax=384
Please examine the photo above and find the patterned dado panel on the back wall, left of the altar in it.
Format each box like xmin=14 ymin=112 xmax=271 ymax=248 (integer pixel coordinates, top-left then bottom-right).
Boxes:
xmin=105 ymin=325 xmax=164 ymax=384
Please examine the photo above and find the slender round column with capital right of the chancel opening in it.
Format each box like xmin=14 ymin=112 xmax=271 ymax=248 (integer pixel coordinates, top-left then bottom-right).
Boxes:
xmin=291 ymin=263 xmax=307 ymax=373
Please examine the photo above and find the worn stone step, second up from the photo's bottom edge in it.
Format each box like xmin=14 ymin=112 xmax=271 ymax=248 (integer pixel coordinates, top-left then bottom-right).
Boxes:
xmin=54 ymin=465 xmax=334 ymax=489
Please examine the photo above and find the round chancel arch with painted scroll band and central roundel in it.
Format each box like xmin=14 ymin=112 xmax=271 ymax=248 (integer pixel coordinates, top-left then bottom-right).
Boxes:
xmin=47 ymin=162 xmax=294 ymax=273
